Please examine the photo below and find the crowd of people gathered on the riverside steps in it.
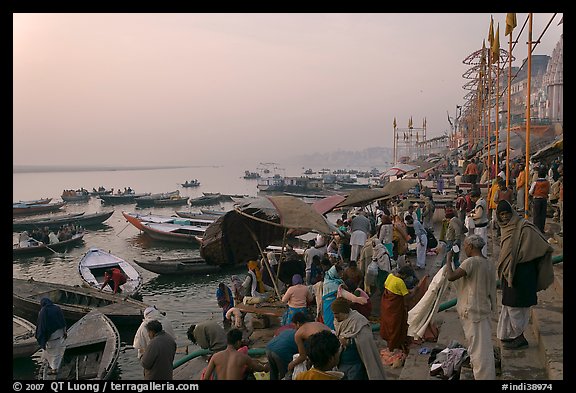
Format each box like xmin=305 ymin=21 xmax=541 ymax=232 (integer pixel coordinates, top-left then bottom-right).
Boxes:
xmin=32 ymin=150 xmax=563 ymax=380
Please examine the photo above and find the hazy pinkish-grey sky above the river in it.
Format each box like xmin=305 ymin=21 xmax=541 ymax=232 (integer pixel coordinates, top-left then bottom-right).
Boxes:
xmin=13 ymin=13 xmax=563 ymax=169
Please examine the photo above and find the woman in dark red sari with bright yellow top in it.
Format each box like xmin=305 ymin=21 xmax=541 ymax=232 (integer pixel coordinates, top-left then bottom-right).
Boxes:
xmin=380 ymin=265 xmax=411 ymax=353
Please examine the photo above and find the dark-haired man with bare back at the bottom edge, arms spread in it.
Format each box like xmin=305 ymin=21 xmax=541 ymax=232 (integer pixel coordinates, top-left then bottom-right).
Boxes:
xmin=202 ymin=329 xmax=270 ymax=381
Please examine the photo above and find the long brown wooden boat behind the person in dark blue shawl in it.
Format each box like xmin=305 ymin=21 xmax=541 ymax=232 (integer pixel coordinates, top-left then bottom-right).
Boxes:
xmin=12 ymin=278 xmax=148 ymax=327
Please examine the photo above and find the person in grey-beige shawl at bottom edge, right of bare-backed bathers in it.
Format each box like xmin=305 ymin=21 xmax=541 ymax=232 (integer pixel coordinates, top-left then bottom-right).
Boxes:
xmin=331 ymin=298 xmax=386 ymax=380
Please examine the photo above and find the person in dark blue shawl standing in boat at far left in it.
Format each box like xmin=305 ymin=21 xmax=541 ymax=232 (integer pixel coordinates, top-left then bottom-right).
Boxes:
xmin=35 ymin=297 xmax=66 ymax=374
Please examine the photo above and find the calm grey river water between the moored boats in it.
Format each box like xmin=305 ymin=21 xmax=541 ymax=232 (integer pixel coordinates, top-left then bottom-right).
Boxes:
xmin=12 ymin=162 xmax=374 ymax=380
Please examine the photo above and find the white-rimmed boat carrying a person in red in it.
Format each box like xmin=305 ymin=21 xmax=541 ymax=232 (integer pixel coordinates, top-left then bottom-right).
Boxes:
xmin=78 ymin=247 xmax=142 ymax=296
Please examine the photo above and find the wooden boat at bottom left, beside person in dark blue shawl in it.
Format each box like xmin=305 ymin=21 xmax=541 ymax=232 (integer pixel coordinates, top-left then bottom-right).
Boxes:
xmin=40 ymin=310 xmax=120 ymax=380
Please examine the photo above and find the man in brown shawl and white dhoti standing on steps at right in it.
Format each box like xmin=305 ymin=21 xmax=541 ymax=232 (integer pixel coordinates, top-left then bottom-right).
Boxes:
xmin=496 ymin=201 xmax=554 ymax=349
